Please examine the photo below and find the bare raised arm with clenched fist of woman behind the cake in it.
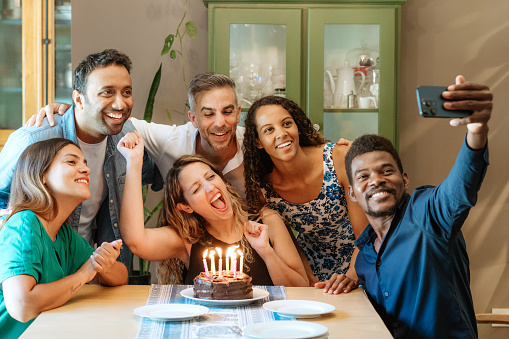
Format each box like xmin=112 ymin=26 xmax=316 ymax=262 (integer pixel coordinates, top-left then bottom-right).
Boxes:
xmin=117 ymin=132 xmax=187 ymax=262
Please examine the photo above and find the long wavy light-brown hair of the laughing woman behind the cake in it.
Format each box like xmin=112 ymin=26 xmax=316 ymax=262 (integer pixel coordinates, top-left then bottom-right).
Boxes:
xmin=157 ymin=154 xmax=259 ymax=284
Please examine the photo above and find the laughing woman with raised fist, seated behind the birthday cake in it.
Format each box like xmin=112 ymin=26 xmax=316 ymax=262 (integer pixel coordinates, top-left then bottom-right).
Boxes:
xmin=118 ymin=132 xmax=309 ymax=286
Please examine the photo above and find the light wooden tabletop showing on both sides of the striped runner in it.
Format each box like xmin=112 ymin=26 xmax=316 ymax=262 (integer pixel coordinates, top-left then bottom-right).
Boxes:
xmin=22 ymin=285 xmax=392 ymax=339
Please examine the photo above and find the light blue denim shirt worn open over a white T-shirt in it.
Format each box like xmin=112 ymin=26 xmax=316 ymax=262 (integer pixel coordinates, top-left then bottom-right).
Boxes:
xmin=0 ymin=107 xmax=163 ymax=269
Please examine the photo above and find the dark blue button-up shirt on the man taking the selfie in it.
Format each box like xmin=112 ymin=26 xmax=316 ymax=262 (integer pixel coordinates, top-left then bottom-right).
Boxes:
xmin=355 ymin=142 xmax=488 ymax=339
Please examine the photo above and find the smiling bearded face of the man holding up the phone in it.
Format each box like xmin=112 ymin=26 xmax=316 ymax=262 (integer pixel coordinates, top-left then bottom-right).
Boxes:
xmin=349 ymin=151 xmax=408 ymax=218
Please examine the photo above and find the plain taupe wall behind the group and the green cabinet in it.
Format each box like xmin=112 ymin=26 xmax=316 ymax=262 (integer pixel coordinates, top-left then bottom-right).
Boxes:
xmin=72 ymin=0 xmax=509 ymax=339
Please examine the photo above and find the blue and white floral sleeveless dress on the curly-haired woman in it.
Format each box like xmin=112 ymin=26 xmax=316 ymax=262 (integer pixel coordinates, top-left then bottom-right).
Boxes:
xmin=262 ymin=143 xmax=355 ymax=281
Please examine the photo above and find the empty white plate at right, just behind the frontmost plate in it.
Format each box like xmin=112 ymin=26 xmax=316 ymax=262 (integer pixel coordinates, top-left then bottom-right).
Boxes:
xmin=263 ymin=300 xmax=336 ymax=318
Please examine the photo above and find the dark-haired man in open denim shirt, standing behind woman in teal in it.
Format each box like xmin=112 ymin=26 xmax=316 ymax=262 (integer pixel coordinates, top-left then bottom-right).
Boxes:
xmin=0 ymin=49 xmax=163 ymax=274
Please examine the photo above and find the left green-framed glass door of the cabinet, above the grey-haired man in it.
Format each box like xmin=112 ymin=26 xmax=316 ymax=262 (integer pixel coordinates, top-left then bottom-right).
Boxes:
xmin=209 ymin=8 xmax=302 ymax=119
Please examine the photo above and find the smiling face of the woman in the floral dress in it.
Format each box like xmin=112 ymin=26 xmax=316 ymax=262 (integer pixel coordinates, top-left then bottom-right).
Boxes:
xmin=255 ymin=105 xmax=300 ymax=160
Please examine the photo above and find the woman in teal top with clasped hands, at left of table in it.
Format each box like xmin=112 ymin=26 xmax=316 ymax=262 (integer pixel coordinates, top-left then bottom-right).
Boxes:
xmin=0 ymin=139 xmax=127 ymax=338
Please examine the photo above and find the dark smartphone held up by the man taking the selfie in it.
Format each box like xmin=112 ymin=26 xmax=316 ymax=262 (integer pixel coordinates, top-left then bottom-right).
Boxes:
xmin=417 ymin=86 xmax=473 ymax=118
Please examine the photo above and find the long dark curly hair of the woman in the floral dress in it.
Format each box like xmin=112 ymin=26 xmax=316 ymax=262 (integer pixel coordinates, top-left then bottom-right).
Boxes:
xmin=244 ymin=96 xmax=326 ymax=213
